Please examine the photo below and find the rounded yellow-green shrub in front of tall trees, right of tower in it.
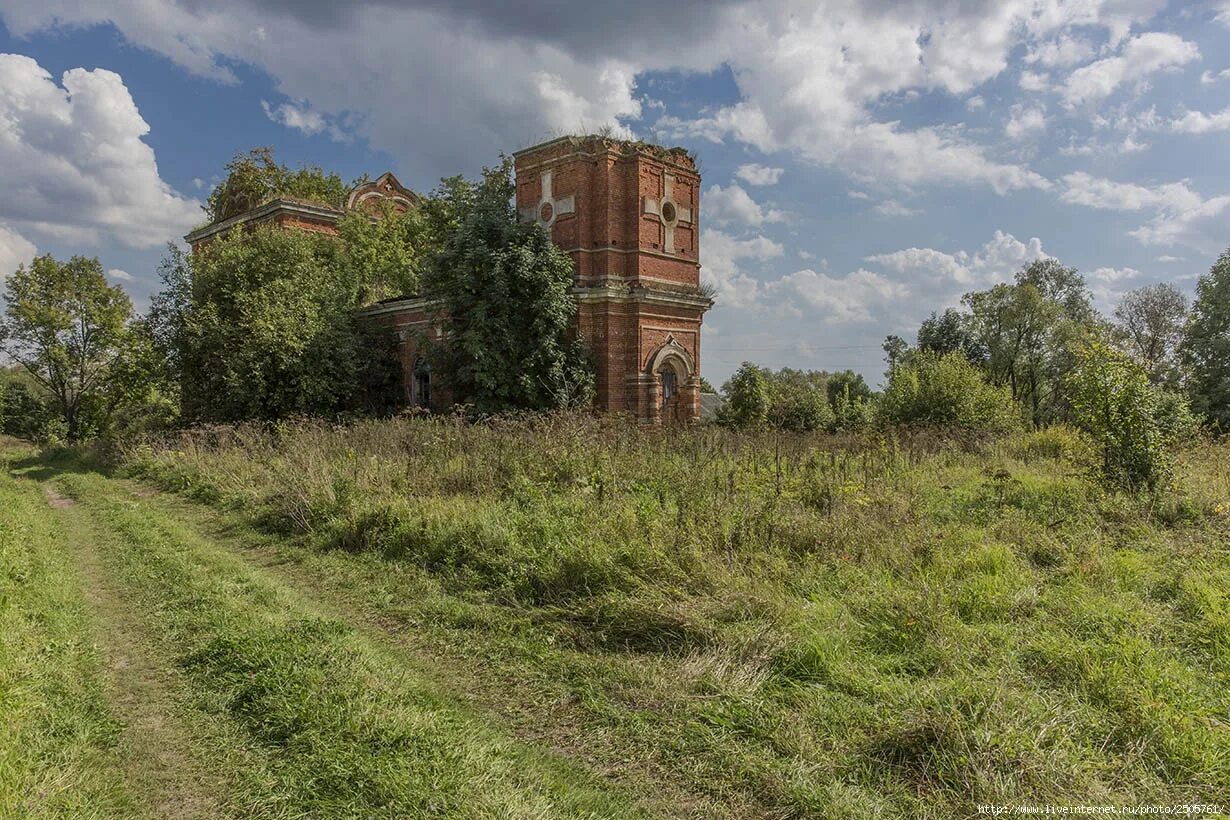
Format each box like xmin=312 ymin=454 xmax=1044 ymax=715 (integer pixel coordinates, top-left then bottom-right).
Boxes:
xmin=879 ymin=350 xmax=1021 ymax=433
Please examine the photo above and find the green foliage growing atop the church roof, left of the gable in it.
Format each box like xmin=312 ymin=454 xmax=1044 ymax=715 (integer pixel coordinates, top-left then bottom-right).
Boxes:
xmin=205 ymin=148 xmax=353 ymax=223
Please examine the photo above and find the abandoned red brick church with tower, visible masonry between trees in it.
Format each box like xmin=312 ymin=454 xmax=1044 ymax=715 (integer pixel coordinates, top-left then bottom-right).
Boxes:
xmin=185 ymin=136 xmax=712 ymax=424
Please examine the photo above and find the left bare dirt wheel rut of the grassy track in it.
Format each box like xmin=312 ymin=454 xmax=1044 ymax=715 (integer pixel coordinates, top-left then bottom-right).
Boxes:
xmin=44 ymin=484 xmax=223 ymax=818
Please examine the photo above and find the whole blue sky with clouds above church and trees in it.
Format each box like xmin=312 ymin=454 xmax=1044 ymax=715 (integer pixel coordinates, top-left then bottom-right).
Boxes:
xmin=0 ymin=0 xmax=1230 ymax=382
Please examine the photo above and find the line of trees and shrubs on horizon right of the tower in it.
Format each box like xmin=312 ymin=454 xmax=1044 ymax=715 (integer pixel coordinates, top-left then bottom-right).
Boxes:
xmin=718 ymin=250 xmax=1230 ymax=487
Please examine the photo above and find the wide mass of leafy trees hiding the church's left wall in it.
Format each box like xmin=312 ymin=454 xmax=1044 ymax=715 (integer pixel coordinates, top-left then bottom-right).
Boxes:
xmin=151 ymin=226 xmax=391 ymax=422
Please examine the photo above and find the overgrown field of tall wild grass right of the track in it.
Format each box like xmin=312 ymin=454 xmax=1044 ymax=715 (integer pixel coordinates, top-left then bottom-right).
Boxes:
xmin=113 ymin=417 xmax=1230 ymax=818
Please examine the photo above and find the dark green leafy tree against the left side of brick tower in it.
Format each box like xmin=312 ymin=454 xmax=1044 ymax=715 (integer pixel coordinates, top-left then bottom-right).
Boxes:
xmin=423 ymin=159 xmax=594 ymax=413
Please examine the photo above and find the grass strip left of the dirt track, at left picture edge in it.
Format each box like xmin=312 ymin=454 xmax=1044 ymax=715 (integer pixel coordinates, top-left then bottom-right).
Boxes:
xmin=0 ymin=449 xmax=137 ymax=818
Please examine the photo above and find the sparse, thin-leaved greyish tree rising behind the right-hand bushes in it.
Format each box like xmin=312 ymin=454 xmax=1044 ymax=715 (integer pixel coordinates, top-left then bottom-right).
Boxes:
xmin=1114 ymin=283 xmax=1187 ymax=386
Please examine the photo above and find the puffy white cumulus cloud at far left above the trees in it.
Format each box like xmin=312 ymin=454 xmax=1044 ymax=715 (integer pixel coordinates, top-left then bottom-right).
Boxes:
xmin=0 ymin=54 xmax=202 ymax=248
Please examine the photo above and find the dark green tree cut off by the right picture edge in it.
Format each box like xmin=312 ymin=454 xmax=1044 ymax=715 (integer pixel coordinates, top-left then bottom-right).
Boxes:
xmin=1180 ymin=248 xmax=1230 ymax=432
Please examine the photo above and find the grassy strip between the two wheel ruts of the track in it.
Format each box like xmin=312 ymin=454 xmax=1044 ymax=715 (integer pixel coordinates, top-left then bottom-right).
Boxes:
xmin=57 ymin=473 xmax=637 ymax=818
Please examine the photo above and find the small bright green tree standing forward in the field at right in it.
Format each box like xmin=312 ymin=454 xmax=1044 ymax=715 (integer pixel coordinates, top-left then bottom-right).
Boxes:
xmin=1066 ymin=341 xmax=1189 ymax=489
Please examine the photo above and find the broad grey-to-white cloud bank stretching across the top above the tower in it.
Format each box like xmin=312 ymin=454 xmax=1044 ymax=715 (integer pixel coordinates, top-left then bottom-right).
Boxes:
xmin=0 ymin=0 xmax=1164 ymax=199
